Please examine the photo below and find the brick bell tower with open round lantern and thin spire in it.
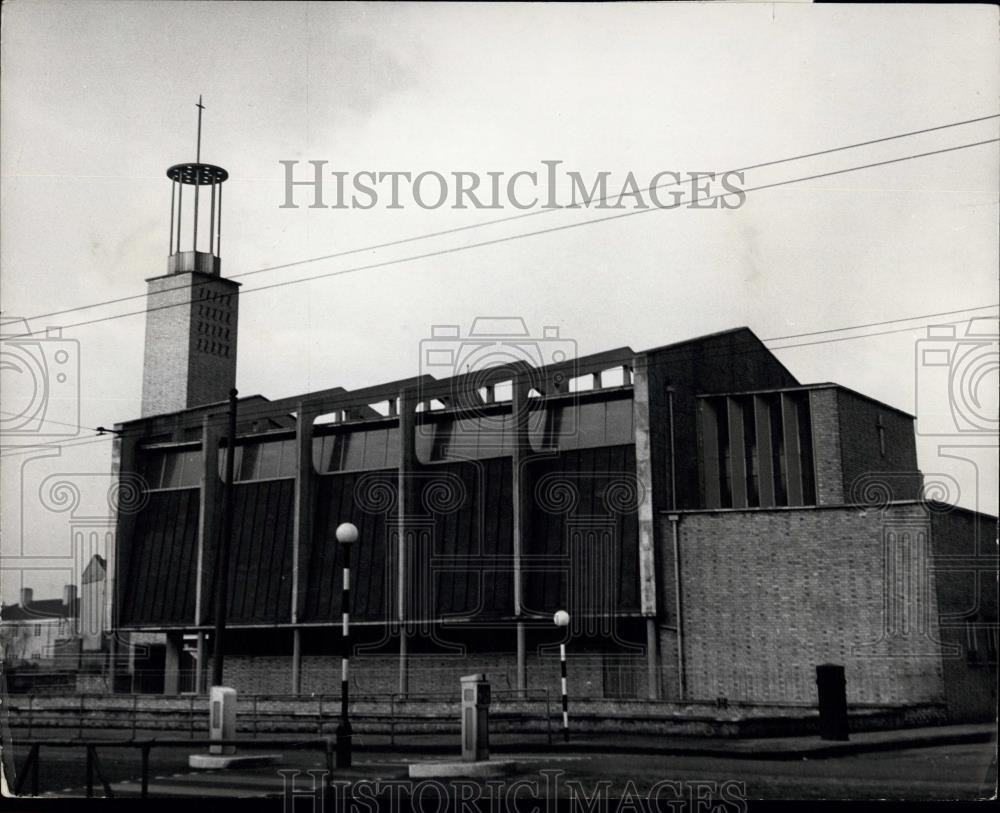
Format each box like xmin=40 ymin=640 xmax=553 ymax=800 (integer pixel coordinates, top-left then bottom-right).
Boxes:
xmin=142 ymin=96 xmax=240 ymax=417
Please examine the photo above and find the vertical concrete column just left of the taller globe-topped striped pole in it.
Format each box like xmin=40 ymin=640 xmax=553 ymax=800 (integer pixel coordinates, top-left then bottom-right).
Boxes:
xmin=290 ymin=403 xmax=319 ymax=694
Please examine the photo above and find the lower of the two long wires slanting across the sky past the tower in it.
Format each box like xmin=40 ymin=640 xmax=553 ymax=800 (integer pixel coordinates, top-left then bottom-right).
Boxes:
xmin=17 ymin=138 xmax=1000 ymax=335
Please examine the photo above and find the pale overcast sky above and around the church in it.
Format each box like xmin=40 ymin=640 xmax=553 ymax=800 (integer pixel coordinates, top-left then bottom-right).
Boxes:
xmin=0 ymin=0 xmax=1000 ymax=603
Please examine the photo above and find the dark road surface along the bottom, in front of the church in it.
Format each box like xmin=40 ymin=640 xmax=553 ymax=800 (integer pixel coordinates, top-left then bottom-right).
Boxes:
xmin=16 ymin=744 xmax=996 ymax=810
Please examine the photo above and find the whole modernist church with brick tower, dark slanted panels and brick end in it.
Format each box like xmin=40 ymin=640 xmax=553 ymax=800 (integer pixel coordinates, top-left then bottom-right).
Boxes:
xmin=112 ymin=147 xmax=997 ymax=720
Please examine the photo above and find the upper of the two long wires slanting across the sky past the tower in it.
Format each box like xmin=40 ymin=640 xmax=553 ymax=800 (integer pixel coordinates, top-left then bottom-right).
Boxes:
xmin=15 ymin=114 xmax=1000 ymax=324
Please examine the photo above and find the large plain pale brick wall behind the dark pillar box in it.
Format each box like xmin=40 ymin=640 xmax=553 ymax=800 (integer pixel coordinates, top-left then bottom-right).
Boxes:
xmin=663 ymin=505 xmax=944 ymax=703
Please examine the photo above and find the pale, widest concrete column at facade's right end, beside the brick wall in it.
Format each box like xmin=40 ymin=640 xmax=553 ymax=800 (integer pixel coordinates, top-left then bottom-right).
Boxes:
xmin=632 ymin=356 xmax=660 ymax=700
